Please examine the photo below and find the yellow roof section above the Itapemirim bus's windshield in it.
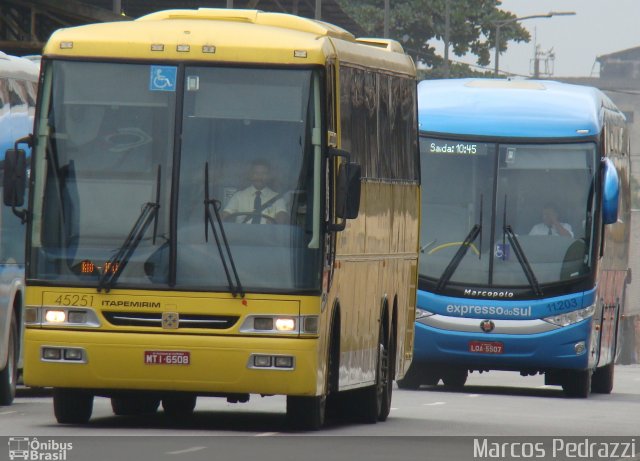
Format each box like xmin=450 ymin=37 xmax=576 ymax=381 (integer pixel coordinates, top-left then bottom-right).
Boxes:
xmin=43 ymin=8 xmax=415 ymax=75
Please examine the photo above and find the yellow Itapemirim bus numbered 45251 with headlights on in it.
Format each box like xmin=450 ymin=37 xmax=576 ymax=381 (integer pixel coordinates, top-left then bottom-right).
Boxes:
xmin=5 ymin=9 xmax=420 ymax=429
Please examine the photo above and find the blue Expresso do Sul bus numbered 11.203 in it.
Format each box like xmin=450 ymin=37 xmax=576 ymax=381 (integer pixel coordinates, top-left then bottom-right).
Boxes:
xmin=399 ymin=79 xmax=630 ymax=397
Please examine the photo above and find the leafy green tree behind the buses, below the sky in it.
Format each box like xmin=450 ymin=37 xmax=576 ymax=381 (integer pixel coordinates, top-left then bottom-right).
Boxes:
xmin=339 ymin=0 xmax=531 ymax=73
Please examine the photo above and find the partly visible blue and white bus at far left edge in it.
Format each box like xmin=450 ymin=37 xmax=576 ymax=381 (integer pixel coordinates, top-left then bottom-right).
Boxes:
xmin=0 ymin=52 xmax=40 ymax=405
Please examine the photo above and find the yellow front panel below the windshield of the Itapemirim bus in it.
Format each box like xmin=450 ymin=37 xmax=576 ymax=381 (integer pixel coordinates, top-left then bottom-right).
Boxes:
xmin=24 ymin=286 xmax=324 ymax=395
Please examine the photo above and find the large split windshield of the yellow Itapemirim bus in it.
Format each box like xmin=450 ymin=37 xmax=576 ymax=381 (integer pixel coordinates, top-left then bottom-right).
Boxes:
xmin=30 ymin=61 xmax=321 ymax=292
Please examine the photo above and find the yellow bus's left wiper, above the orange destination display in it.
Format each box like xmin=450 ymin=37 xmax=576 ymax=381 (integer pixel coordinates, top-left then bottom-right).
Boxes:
xmin=98 ymin=165 xmax=160 ymax=293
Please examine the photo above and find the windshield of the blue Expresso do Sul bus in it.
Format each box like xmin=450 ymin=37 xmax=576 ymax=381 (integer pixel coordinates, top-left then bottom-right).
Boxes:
xmin=420 ymin=137 xmax=596 ymax=292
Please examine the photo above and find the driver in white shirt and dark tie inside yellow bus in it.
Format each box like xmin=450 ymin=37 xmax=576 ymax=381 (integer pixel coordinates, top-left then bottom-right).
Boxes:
xmin=222 ymin=160 xmax=289 ymax=224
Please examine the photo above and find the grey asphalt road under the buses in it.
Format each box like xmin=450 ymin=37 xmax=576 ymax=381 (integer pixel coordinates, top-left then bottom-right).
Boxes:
xmin=0 ymin=365 xmax=640 ymax=461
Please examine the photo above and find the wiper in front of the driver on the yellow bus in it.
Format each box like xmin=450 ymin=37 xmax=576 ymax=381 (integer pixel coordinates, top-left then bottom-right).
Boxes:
xmin=204 ymin=162 xmax=244 ymax=298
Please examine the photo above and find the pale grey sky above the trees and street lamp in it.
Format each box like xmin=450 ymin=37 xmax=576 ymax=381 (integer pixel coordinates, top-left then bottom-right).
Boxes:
xmin=439 ymin=0 xmax=640 ymax=77
